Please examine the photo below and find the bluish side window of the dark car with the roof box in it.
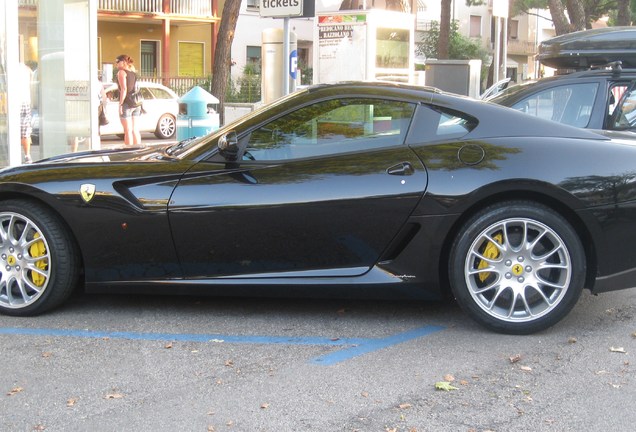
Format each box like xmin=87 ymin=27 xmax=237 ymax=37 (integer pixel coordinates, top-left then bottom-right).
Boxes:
xmin=512 ymin=83 xmax=598 ymax=127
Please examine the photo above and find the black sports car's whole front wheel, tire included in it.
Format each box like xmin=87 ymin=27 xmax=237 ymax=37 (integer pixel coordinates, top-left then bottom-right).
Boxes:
xmin=0 ymin=199 xmax=80 ymax=316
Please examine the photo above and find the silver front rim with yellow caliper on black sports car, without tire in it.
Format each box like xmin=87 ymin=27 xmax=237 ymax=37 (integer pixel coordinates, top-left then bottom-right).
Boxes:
xmin=0 ymin=212 xmax=51 ymax=309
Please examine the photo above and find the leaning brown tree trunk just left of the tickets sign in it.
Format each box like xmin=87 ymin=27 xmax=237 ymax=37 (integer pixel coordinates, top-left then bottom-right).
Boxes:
xmin=212 ymin=0 xmax=241 ymax=124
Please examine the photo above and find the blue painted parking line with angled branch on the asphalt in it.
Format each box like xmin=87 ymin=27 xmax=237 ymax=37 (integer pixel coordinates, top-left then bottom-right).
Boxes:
xmin=0 ymin=326 xmax=444 ymax=366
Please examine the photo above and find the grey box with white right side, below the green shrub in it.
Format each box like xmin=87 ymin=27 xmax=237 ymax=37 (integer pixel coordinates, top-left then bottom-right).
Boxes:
xmin=424 ymin=59 xmax=481 ymax=99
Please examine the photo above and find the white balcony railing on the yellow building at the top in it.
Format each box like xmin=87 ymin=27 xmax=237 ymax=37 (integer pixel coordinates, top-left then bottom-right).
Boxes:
xmin=98 ymin=0 xmax=213 ymax=18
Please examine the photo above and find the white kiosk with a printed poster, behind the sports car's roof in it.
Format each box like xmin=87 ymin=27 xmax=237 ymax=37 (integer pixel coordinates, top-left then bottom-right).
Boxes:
xmin=313 ymin=9 xmax=415 ymax=84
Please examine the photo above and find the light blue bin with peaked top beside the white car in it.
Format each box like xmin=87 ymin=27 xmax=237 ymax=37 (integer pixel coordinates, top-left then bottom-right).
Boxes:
xmin=177 ymin=86 xmax=219 ymax=141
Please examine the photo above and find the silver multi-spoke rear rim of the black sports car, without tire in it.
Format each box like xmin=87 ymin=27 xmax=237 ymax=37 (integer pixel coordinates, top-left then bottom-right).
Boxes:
xmin=464 ymin=218 xmax=572 ymax=323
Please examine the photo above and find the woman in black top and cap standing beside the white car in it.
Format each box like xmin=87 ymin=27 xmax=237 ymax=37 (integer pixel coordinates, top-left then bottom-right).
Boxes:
xmin=116 ymin=54 xmax=141 ymax=145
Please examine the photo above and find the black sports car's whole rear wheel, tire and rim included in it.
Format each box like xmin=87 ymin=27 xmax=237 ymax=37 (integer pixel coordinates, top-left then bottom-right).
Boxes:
xmin=448 ymin=201 xmax=586 ymax=334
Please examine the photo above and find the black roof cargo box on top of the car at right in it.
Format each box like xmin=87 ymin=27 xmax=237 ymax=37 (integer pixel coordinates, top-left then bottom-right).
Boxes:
xmin=537 ymin=27 xmax=636 ymax=69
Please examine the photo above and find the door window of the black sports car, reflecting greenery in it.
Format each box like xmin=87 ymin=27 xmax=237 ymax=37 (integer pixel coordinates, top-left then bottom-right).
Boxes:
xmin=247 ymin=98 xmax=414 ymax=160
